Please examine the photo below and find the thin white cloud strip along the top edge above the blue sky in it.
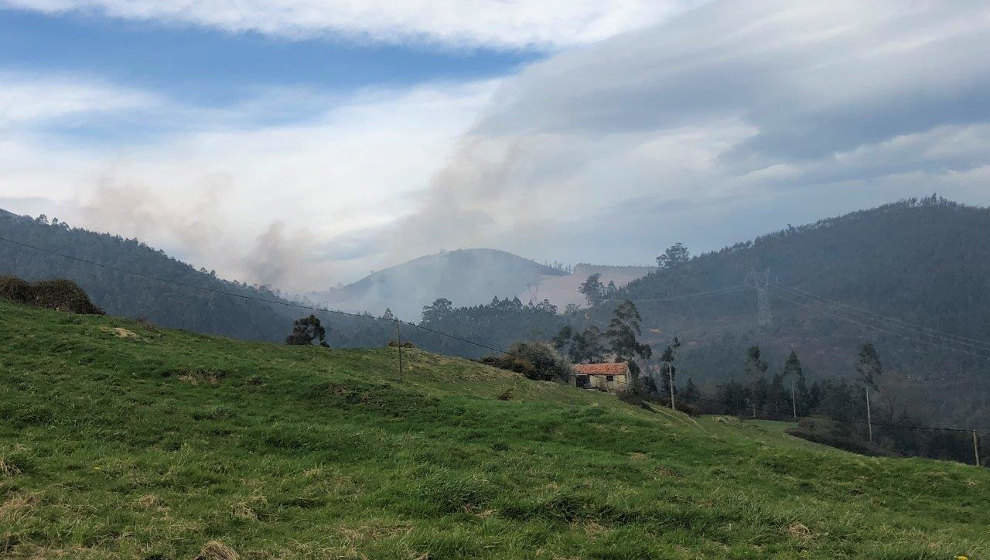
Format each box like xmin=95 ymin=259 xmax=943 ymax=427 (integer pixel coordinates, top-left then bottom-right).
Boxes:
xmin=0 ymin=0 xmax=700 ymax=48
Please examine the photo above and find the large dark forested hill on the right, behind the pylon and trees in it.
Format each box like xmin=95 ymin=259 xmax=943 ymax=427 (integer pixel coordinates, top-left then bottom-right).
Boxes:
xmin=589 ymin=197 xmax=990 ymax=420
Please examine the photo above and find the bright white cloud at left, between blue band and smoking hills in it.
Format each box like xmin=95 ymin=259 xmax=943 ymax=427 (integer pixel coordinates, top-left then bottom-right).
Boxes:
xmin=0 ymin=75 xmax=495 ymax=289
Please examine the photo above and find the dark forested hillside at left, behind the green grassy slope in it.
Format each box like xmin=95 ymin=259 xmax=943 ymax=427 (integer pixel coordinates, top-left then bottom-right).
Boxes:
xmin=0 ymin=210 xmax=414 ymax=347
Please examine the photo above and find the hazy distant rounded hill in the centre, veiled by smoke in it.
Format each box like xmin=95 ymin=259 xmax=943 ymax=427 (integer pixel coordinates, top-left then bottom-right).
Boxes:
xmin=308 ymin=249 xmax=567 ymax=321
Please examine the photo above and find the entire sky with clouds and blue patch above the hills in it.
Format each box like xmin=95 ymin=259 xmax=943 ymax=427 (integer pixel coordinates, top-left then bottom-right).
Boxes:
xmin=0 ymin=0 xmax=990 ymax=292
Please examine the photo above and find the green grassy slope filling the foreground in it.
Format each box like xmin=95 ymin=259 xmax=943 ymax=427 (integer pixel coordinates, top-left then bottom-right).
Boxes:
xmin=0 ymin=303 xmax=990 ymax=559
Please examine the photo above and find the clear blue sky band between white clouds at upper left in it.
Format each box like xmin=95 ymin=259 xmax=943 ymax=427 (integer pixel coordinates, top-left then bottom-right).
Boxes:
xmin=0 ymin=8 xmax=546 ymax=107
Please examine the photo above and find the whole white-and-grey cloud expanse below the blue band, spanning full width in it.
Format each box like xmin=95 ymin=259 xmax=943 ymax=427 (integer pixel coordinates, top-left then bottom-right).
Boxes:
xmin=0 ymin=0 xmax=990 ymax=289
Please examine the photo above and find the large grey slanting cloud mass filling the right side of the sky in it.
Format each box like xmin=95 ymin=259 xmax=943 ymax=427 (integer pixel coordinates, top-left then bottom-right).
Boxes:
xmin=382 ymin=0 xmax=990 ymax=263
